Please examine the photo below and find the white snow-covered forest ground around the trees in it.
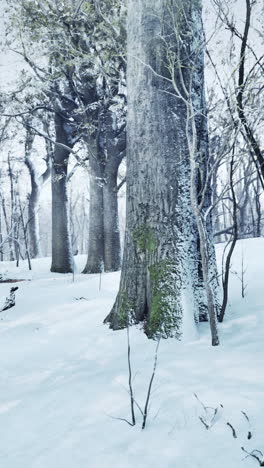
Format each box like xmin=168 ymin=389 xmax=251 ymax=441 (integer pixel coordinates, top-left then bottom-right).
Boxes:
xmin=0 ymin=239 xmax=264 ymax=468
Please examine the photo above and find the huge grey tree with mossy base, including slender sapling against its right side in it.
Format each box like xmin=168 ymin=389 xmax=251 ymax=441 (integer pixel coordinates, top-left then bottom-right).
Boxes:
xmin=105 ymin=0 xmax=218 ymax=345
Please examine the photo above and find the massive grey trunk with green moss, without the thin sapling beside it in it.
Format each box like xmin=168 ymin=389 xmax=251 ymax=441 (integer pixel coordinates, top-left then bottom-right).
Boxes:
xmin=105 ymin=0 xmax=212 ymax=337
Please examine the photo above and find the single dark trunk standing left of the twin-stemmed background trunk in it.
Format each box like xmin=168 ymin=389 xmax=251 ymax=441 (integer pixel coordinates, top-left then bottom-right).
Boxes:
xmin=51 ymin=114 xmax=73 ymax=273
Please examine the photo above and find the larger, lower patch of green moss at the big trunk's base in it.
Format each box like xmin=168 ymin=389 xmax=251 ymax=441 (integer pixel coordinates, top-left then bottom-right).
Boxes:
xmin=148 ymin=259 xmax=181 ymax=338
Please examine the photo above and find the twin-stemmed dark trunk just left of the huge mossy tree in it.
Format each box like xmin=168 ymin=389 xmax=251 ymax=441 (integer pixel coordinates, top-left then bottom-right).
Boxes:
xmin=84 ymin=111 xmax=126 ymax=273
